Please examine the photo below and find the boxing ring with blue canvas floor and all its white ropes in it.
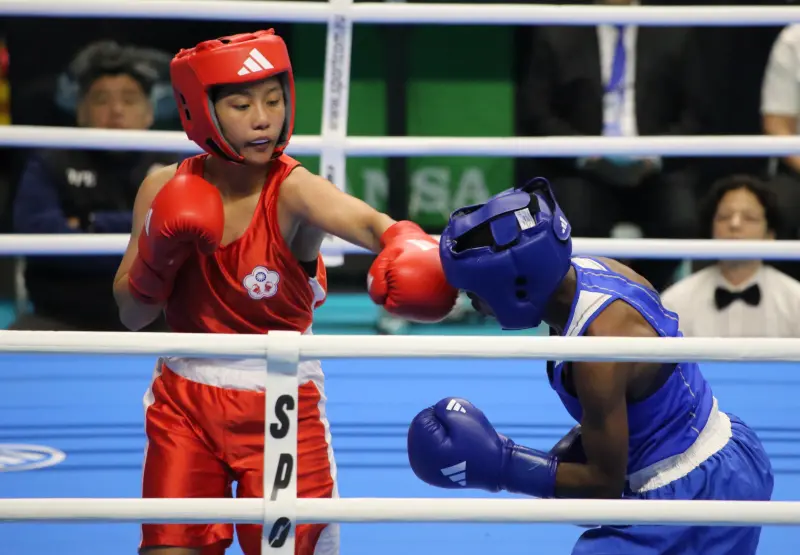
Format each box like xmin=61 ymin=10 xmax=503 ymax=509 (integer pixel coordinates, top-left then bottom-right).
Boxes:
xmin=0 ymin=0 xmax=800 ymax=555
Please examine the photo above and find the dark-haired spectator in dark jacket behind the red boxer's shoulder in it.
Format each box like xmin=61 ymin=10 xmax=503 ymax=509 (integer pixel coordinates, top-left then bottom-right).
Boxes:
xmin=11 ymin=41 xmax=178 ymax=331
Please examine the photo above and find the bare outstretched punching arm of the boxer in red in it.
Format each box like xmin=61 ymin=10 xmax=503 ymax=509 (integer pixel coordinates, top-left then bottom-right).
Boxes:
xmin=281 ymin=166 xmax=395 ymax=253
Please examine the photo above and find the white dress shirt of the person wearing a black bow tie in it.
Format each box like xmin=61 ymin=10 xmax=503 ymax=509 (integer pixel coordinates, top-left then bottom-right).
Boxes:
xmin=661 ymin=265 xmax=800 ymax=337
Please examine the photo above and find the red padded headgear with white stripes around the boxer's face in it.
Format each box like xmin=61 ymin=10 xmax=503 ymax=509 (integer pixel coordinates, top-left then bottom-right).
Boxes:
xmin=170 ymin=29 xmax=294 ymax=163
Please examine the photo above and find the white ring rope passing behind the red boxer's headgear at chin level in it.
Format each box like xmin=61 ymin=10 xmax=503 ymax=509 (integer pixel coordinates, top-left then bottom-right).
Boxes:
xmin=7 ymin=125 xmax=800 ymax=158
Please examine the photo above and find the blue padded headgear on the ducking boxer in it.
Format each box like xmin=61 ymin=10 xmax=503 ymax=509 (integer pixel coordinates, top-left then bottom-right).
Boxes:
xmin=439 ymin=177 xmax=572 ymax=329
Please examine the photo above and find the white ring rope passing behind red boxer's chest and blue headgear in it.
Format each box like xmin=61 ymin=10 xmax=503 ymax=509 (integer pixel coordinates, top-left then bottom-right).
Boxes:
xmin=0 ymin=234 xmax=800 ymax=260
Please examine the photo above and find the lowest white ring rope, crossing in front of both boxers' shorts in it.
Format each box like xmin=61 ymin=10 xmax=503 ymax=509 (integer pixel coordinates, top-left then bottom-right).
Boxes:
xmin=0 ymin=498 xmax=800 ymax=526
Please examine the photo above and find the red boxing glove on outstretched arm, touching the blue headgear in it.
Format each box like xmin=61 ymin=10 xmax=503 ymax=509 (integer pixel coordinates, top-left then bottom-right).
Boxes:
xmin=367 ymin=221 xmax=458 ymax=322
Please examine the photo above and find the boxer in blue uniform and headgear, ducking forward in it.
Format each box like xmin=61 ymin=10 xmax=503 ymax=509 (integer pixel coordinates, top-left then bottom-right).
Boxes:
xmin=408 ymin=179 xmax=773 ymax=555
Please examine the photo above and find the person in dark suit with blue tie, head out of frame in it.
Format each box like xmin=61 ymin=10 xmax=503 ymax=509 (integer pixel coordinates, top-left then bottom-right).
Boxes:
xmin=518 ymin=0 xmax=703 ymax=290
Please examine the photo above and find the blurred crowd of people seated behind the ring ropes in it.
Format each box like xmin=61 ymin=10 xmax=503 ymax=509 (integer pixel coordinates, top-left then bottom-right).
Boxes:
xmin=0 ymin=0 xmax=800 ymax=336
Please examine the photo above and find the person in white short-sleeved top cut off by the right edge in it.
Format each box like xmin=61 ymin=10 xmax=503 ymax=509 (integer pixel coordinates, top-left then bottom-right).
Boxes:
xmin=761 ymin=25 xmax=800 ymax=279
